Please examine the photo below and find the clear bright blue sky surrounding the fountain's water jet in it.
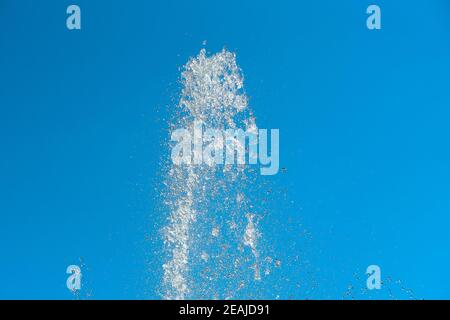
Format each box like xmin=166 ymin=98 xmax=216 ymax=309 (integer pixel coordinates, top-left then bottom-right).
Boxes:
xmin=0 ymin=0 xmax=450 ymax=299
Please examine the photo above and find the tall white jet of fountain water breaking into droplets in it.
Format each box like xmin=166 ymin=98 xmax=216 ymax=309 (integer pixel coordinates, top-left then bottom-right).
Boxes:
xmin=163 ymin=49 xmax=261 ymax=299
